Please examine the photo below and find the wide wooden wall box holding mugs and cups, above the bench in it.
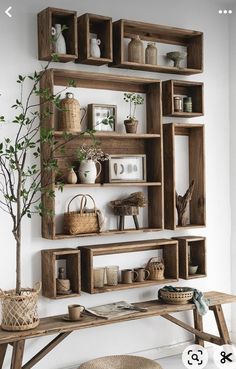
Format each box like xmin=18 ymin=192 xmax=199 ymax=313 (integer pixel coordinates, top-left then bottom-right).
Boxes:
xmin=79 ymin=239 xmax=178 ymax=294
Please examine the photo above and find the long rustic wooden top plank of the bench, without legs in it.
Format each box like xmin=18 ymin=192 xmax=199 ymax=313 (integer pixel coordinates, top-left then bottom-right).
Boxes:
xmin=0 ymin=291 xmax=236 ymax=344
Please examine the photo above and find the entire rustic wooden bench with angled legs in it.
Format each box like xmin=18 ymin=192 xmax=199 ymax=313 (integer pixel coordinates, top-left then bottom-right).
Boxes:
xmin=0 ymin=292 xmax=236 ymax=369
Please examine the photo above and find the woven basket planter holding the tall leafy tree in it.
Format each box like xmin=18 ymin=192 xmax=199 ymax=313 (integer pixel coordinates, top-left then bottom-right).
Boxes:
xmin=0 ymin=284 xmax=41 ymax=331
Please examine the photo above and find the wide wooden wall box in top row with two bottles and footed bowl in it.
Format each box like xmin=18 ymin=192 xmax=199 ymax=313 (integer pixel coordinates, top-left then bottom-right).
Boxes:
xmin=111 ymin=19 xmax=203 ymax=75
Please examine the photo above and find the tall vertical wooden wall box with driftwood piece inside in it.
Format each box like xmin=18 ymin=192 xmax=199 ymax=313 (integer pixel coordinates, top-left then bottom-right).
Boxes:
xmin=163 ymin=123 xmax=205 ymax=230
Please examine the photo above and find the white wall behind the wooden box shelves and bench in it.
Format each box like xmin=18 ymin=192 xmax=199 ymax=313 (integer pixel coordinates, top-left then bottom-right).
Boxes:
xmin=0 ymin=0 xmax=231 ymax=369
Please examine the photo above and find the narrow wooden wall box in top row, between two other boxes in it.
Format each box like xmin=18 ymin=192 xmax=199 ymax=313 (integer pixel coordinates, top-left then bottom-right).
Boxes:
xmin=76 ymin=13 xmax=113 ymax=65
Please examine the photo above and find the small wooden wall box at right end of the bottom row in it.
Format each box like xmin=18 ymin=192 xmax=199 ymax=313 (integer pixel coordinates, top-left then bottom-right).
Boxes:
xmin=173 ymin=236 xmax=207 ymax=279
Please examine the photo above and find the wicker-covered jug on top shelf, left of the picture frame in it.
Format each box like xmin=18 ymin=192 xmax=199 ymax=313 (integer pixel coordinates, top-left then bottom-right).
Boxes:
xmin=58 ymin=92 xmax=87 ymax=132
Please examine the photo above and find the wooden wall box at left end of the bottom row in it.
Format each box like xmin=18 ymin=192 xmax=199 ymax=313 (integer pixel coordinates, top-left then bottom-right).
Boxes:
xmin=41 ymin=248 xmax=81 ymax=299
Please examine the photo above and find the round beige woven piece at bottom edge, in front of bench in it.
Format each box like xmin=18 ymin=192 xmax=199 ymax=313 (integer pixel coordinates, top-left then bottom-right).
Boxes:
xmin=79 ymin=355 xmax=162 ymax=369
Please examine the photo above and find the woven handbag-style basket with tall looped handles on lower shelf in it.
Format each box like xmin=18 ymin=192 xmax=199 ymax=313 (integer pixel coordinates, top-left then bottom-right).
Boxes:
xmin=64 ymin=194 xmax=99 ymax=234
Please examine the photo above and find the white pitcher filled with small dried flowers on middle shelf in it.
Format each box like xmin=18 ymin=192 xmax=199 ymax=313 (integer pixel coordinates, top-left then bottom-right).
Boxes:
xmin=76 ymin=143 xmax=109 ymax=183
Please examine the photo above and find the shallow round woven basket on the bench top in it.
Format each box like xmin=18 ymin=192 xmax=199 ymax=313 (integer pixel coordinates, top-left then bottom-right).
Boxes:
xmin=159 ymin=287 xmax=193 ymax=305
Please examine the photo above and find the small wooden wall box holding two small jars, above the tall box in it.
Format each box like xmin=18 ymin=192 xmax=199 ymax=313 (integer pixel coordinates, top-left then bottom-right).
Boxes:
xmin=162 ymin=80 xmax=204 ymax=118
